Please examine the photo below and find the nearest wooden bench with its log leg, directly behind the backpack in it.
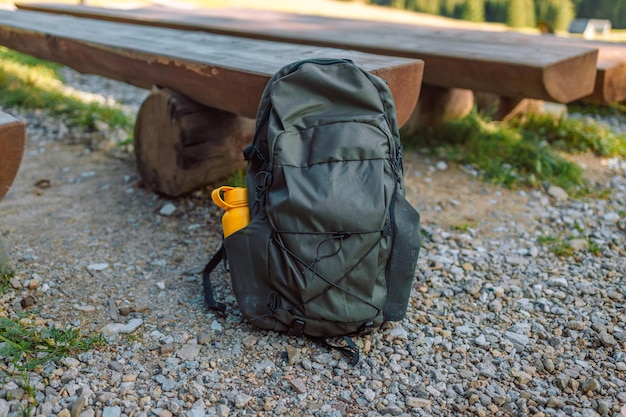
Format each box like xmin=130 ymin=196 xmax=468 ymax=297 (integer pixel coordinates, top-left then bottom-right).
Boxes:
xmin=0 ymin=10 xmax=424 ymax=196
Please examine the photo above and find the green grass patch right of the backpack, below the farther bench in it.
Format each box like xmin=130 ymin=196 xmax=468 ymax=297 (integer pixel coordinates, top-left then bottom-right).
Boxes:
xmin=403 ymin=106 xmax=626 ymax=192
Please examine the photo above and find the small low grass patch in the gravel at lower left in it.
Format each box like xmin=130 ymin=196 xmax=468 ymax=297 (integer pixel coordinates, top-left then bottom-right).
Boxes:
xmin=0 ymin=318 xmax=106 ymax=371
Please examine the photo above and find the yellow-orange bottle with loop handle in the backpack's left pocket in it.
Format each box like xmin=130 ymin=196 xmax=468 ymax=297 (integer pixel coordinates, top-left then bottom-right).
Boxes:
xmin=211 ymin=185 xmax=250 ymax=237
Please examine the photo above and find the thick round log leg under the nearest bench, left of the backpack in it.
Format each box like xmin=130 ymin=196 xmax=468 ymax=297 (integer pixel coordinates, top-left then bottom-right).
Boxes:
xmin=134 ymin=87 xmax=255 ymax=197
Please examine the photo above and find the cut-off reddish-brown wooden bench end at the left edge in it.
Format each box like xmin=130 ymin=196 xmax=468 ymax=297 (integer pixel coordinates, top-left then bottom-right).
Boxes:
xmin=0 ymin=112 xmax=26 ymax=201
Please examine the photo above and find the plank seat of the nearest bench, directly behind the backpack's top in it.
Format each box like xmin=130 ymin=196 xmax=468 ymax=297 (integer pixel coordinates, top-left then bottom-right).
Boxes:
xmin=0 ymin=10 xmax=424 ymax=124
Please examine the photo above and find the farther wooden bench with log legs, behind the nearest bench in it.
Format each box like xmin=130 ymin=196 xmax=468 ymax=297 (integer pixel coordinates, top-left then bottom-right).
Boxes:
xmin=16 ymin=3 xmax=626 ymax=128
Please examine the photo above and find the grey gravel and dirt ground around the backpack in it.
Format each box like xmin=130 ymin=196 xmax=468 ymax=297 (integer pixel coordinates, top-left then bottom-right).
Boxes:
xmin=0 ymin=71 xmax=626 ymax=417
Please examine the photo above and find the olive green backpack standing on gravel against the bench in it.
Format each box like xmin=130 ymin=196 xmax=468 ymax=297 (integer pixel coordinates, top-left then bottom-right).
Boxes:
xmin=204 ymin=59 xmax=420 ymax=360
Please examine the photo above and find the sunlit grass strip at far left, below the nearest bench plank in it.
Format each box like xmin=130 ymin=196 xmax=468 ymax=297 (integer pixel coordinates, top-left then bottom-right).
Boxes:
xmin=0 ymin=47 xmax=134 ymax=131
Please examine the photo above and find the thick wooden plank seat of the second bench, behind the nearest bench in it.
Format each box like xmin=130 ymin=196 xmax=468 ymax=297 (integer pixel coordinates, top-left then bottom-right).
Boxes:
xmin=13 ymin=4 xmax=598 ymax=103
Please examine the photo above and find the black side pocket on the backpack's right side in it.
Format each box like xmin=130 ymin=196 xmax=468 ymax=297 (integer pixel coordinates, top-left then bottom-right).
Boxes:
xmin=383 ymin=192 xmax=421 ymax=321
